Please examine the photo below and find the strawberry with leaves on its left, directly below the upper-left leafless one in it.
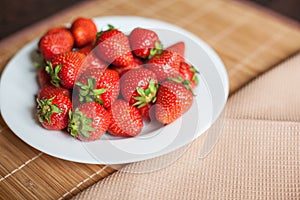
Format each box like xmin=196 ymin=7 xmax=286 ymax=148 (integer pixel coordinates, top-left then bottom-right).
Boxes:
xmin=46 ymin=51 xmax=85 ymax=89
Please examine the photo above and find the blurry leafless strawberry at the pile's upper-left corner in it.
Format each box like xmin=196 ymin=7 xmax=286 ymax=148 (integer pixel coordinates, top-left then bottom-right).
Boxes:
xmin=38 ymin=27 xmax=74 ymax=61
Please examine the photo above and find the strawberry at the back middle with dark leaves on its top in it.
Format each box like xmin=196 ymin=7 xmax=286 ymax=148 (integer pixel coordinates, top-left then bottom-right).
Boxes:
xmin=95 ymin=25 xmax=133 ymax=67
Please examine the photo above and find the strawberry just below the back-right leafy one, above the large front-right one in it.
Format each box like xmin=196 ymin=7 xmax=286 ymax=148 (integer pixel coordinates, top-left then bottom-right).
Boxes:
xmin=146 ymin=51 xmax=181 ymax=82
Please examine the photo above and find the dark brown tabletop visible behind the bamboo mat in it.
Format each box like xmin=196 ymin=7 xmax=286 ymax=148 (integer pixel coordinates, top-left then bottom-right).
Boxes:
xmin=0 ymin=0 xmax=300 ymax=40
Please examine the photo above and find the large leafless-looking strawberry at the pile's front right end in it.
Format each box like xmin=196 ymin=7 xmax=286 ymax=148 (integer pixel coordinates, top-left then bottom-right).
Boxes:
xmin=155 ymin=81 xmax=193 ymax=124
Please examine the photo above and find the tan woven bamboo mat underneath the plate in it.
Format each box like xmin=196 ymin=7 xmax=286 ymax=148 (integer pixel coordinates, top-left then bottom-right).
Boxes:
xmin=0 ymin=0 xmax=300 ymax=199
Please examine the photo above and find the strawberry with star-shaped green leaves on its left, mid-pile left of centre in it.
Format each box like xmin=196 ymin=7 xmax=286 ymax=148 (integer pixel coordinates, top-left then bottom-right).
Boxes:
xmin=76 ymin=68 xmax=120 ymax=108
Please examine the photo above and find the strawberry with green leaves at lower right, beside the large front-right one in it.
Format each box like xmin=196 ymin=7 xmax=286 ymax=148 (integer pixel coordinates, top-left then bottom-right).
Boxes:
xmin=120 ymin=68 xmax=158 ymax=118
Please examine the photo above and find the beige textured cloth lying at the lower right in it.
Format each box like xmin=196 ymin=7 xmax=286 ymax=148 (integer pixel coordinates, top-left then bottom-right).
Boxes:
xmin=74 ymin=54 xmax=300 ymax=200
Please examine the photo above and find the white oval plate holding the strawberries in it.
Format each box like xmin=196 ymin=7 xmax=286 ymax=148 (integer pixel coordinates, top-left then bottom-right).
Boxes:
xmin=0 ymin=16 xmax=228 ymax=164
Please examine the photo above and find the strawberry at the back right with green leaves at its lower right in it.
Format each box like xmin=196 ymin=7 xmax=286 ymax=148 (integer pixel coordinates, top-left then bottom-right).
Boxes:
xmin=129 ymin=28 xmax=163 ymax=59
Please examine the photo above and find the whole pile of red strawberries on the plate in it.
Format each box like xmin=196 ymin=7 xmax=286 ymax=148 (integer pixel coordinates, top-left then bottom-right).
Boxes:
xmin=36 ymin=18 xmax=198 ymax=141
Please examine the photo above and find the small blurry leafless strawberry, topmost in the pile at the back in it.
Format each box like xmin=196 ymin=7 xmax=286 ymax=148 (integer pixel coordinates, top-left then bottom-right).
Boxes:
xmin=71 ymin=17 xmax=97 ymax=47
